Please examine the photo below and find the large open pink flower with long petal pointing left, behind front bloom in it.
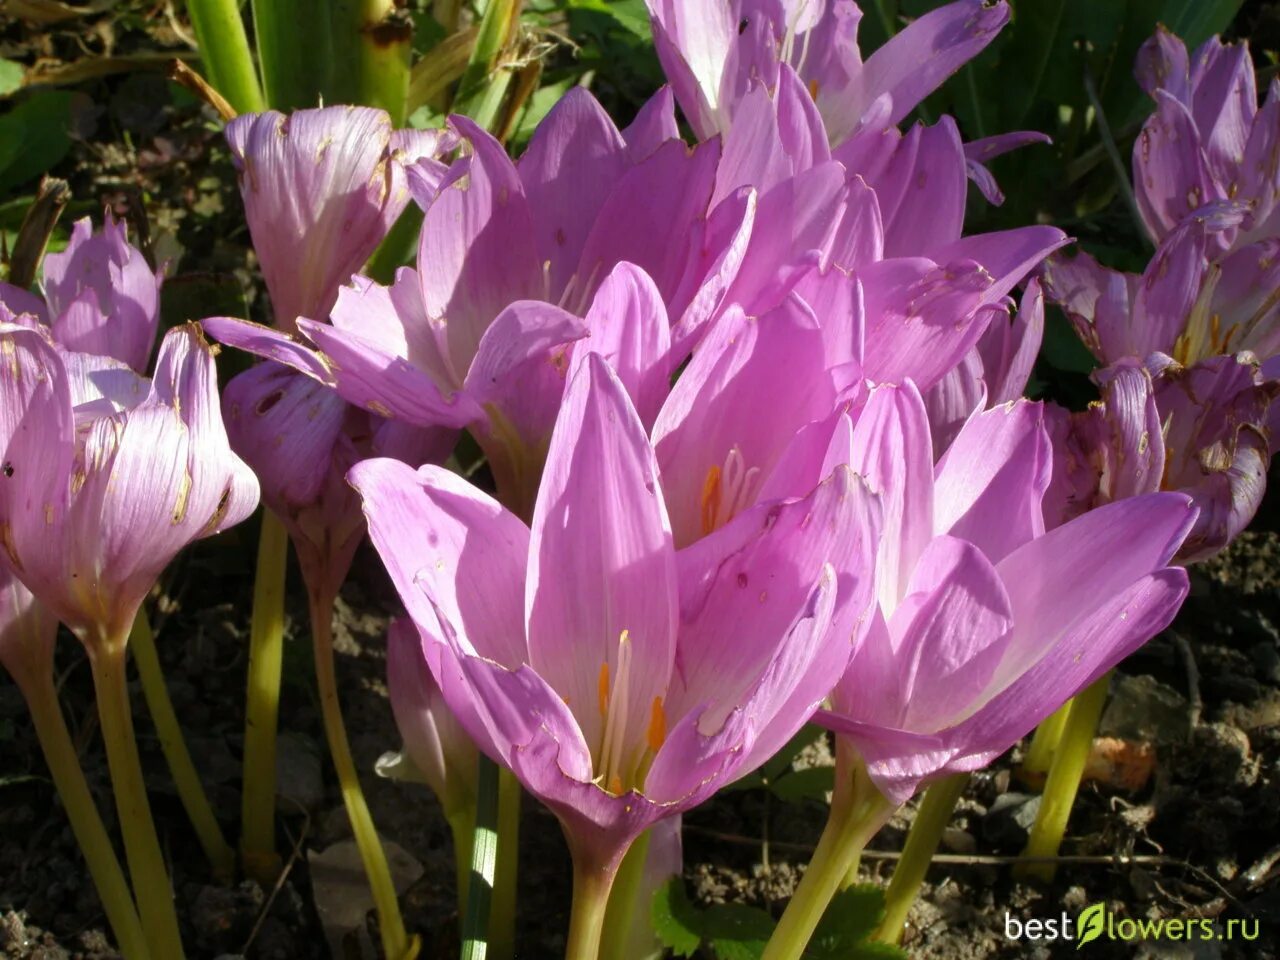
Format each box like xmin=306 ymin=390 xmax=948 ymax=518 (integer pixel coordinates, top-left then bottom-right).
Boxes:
xmin=205 ymin=91 xmax=754 ymax=515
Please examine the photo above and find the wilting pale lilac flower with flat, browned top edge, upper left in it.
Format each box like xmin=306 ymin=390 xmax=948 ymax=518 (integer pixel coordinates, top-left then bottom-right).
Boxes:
xmin=227 ymin=106 xmax=437 ymax=332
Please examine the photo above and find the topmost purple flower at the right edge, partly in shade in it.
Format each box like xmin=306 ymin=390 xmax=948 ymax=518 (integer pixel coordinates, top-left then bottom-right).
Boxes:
xmin=1133 ymin=27 xmax=1280 ymax=255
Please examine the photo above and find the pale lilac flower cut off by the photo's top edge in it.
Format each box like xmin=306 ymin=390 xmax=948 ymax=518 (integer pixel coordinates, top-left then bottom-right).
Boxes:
xmin=646 ymin=0 xmax=1009 ymax=143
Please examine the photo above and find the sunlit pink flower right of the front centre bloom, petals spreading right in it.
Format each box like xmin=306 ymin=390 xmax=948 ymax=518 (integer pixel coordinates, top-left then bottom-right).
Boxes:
xmin=818 ymin=383 xmax=1196 ymax=804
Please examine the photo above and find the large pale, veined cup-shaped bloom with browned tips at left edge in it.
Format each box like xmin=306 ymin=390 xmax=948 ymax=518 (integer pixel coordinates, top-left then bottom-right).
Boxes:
xmin=0 ymin=324 xmax=259 ymax=644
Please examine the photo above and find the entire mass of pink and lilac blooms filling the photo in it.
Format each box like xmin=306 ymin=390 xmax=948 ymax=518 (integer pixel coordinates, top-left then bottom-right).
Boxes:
xmin=0 ymin=0 xmax=1280 ymax=957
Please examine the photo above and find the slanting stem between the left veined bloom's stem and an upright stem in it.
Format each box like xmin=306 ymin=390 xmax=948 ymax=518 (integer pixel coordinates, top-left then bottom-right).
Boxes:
xmin=129 ymin=609 xmax=236 ymax=881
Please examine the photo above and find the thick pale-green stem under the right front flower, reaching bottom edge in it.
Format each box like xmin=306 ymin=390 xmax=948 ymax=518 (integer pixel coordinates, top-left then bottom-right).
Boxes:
xmin=763 ymin=741 xmax=893 ymax=960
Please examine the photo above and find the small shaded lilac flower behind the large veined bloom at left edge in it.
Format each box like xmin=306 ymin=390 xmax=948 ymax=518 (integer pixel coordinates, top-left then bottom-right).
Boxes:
xmin=0 ymin=214 xmax=163 ymax=372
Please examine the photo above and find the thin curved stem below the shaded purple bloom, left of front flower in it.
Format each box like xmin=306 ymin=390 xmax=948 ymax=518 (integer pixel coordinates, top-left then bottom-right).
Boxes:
xmin=307 ymin=590 xmax=421 ymax=960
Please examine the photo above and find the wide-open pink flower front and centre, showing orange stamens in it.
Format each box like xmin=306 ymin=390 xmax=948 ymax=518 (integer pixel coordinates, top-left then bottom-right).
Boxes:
xmin=351 ymin=353 xmax=879 ymax=877
